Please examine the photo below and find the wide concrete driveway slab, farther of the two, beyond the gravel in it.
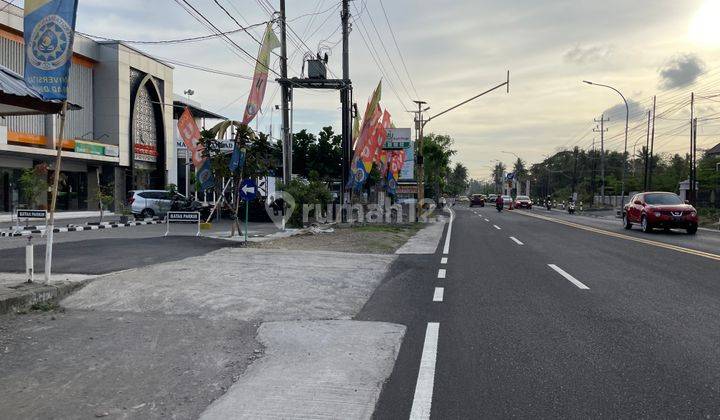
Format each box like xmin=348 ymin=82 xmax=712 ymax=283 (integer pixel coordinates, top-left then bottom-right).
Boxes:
xmin=61 ymin=248 xmax=395 ymax=321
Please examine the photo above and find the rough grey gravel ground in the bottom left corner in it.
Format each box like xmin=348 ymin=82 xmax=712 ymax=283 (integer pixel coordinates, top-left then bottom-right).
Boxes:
xmin=0 ymin=310 xmax=262 ymax=419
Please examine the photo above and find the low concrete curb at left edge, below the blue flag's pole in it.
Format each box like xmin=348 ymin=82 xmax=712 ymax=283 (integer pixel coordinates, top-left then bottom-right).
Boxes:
xmin=0 ymin=278 xmax=95 ymax=315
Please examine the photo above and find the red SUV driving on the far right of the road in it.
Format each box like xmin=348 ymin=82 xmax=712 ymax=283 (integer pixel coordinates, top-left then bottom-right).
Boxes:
xmin=623 ymin=192 xmax=698 ymax=235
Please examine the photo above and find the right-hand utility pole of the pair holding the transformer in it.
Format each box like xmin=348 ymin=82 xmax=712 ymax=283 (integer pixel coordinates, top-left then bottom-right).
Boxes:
xmin=340 ymin=0 xmax=352 ymax=212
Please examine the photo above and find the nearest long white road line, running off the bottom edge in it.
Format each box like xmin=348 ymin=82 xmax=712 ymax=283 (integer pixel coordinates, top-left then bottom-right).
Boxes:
xmin=410 ymin=322 xmax=440 ymax=420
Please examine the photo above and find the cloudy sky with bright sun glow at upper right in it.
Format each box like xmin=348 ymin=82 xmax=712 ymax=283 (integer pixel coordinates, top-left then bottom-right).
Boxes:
xmin=66 ymin=0 xmax=720 ymax=178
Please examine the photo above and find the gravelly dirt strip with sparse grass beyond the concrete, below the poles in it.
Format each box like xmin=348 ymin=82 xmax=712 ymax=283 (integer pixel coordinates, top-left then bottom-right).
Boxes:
xmin=250 ymin=223 xmax=424 ymax=254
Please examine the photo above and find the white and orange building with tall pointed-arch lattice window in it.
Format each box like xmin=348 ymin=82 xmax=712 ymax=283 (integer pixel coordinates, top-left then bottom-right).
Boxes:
xmin=0 ymin=1 xmax=177 ymax=212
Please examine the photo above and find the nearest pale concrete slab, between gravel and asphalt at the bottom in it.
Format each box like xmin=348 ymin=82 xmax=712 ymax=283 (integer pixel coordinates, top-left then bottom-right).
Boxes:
xmin=200 ymin=321 xmax=405 ymax=420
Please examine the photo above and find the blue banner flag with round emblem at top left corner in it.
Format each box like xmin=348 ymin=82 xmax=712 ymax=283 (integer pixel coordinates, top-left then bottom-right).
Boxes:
xmin=24 ymin=0 xmax=78 ymax=101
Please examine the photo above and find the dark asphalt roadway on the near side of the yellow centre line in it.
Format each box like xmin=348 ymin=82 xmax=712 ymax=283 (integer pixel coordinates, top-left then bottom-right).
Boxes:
xmin=357 ymin=203 xmax=720 ymax=419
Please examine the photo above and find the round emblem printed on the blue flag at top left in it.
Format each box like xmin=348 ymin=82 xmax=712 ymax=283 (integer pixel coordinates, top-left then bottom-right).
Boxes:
xmin=27 ymin=15 xmax=72 ymax=70
